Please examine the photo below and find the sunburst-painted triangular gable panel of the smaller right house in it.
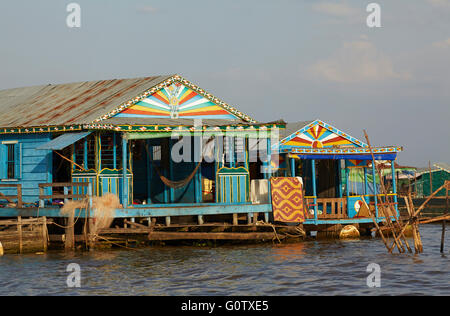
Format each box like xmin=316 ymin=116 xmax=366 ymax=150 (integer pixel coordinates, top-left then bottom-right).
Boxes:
xmin=281 ymin=120 xmax=367 ymax=148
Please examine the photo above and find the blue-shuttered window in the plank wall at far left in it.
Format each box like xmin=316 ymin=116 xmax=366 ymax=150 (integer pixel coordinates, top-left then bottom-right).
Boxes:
xmin=0 ymin=141 xmax=22 ymax=180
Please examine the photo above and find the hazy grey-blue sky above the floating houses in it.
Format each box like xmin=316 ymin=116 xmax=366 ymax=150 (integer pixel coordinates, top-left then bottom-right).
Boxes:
xmin=0 ymin=0 xmax=450 ymax=167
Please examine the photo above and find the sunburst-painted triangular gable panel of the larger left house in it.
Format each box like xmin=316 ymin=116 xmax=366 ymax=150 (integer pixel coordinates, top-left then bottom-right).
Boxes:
xmin=115 ymin=82 xmax=238 ymax=119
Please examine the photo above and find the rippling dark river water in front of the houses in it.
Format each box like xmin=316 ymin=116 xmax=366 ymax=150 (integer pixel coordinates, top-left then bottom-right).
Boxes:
xmin=0 ymin=224 xmax=450 ymax=296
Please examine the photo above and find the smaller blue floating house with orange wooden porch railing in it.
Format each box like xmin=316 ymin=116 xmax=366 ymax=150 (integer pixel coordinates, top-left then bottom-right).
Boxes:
xmin=276 ymin=120 xmax=402 ymax=223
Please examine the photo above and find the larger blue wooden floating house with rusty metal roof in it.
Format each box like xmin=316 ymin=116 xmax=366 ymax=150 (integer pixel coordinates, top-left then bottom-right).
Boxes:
xmin=0 ymin=75 xmax=284 ymax=223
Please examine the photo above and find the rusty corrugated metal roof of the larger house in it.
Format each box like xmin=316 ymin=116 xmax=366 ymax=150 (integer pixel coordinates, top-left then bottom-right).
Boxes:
xmin=0 ymin=75 xmax=173 ymax=127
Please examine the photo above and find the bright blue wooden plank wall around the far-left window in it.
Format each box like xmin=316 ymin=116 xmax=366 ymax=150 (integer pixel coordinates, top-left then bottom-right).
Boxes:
xmin=0 ymin=133 xmax=52 ymax=203
